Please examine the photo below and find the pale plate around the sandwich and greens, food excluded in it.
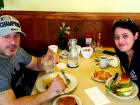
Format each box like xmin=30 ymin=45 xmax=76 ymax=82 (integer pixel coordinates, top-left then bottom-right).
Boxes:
xmin=106 ymin=76 xmax=139 ymax=102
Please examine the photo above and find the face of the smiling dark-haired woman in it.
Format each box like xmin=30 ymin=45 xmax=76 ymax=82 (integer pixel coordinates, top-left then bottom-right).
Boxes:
xmin=114 ymin=27 xmax=138 ymax=53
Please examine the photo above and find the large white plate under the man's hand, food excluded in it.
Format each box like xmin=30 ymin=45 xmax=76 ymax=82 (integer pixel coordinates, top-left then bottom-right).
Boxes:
xmin=35 ymin=72 xmax=77 ymax=94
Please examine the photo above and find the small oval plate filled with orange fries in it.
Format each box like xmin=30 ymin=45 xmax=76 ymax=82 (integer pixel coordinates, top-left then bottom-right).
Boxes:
xmin=91 ymin=70 xmax=112 ymax=82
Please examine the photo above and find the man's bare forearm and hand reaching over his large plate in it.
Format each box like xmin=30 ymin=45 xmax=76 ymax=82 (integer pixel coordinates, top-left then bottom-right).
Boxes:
xmin=0 ymin=76 xmax=65 ymax=105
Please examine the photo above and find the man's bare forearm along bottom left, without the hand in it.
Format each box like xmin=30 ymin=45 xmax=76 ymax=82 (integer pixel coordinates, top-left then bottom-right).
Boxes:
xmin=0 ymin=89 xmax=56 ymax=105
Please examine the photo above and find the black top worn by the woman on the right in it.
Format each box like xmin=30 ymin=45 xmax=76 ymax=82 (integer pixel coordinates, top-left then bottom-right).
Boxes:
xmin=116 ymin=48 xmax=140 ymax=97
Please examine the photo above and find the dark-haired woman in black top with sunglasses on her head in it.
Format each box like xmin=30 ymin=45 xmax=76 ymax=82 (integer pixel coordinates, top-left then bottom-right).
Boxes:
xmin=112 ymin=19 xmax=140 ymax=97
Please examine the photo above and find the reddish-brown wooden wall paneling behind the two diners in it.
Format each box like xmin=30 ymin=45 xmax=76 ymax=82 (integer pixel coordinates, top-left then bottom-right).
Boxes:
xmin=0 ymin=11 xmax=140 ymax=55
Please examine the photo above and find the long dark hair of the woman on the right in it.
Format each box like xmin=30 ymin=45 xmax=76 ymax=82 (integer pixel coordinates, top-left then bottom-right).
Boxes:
xmin=112 ymin=19 xmax=140 ymax=70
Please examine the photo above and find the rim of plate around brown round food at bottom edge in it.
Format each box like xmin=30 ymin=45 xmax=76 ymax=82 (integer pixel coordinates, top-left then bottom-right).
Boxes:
xmin=53 ymin=95 xmax=82 ymax=105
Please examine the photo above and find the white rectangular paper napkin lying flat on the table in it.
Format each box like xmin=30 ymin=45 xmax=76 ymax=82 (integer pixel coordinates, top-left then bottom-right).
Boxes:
xmin=84 ymin=87 xmax=110 ymax=105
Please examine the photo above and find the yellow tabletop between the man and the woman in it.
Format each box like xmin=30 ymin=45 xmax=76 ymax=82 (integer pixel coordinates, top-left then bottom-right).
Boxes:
xmin=31 ymin=47 xmax=140 ymax=105
